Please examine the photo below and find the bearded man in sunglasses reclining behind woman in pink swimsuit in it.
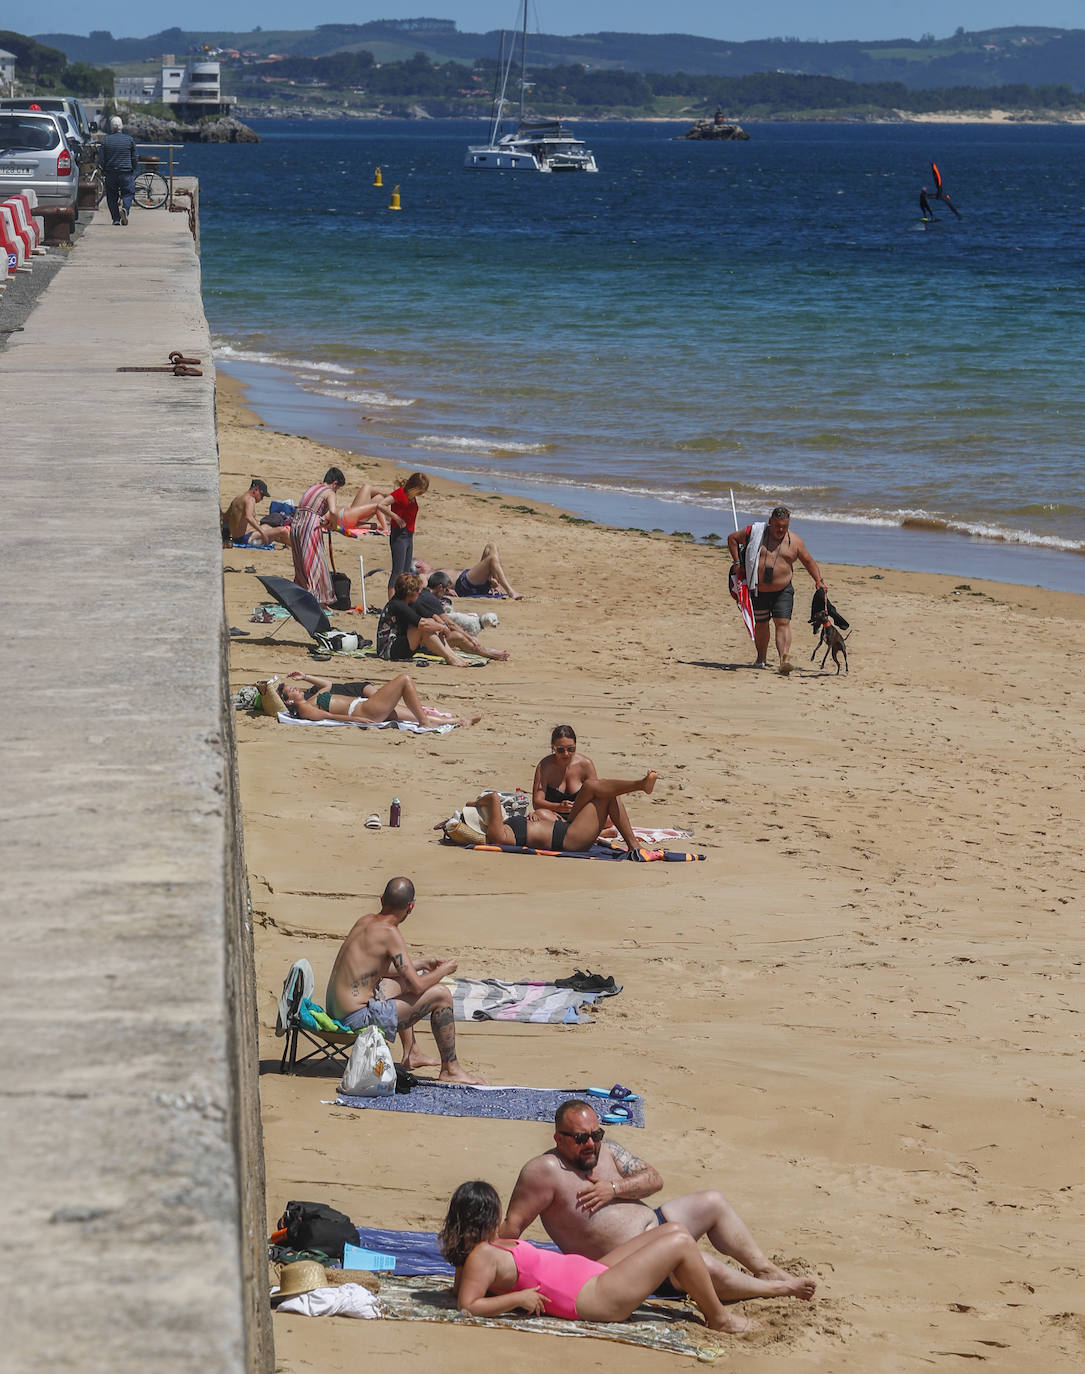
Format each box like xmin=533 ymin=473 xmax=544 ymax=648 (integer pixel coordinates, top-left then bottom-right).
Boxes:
xmin=500 ymin=1098 xmax=816 ymax=1331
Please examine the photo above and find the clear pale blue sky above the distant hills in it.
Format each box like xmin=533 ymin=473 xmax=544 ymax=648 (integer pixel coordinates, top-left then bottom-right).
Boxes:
xmin=8 ymin=0 xmax=1085 ymax=41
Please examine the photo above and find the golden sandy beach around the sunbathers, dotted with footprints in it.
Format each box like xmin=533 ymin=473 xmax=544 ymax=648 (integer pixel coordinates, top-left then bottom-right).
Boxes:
xmin=218 ymin=376 xmax=1085 ymax=1374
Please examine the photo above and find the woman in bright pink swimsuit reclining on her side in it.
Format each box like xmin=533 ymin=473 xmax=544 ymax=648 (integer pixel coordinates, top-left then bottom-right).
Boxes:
xmin=439 ymin=1180 xmax=736 ymax=1331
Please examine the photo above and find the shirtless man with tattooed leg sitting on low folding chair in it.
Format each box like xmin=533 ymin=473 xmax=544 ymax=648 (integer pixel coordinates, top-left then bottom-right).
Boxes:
xmin=324 ymin=878 xmax=482 ymax=1083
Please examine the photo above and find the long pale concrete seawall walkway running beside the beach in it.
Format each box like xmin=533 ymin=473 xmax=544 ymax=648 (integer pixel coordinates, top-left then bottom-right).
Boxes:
xmin=0 ymin=188 xmax=272 ymax=1374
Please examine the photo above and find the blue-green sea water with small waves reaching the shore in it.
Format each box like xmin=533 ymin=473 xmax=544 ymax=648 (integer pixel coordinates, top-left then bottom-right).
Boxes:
xmin=181 ymin=121 xmax=1085 ymax=589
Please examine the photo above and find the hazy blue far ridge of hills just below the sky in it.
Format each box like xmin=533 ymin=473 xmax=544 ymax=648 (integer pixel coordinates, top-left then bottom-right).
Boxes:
xmin=25 ymin=18 xmax=1085 ymax=91
